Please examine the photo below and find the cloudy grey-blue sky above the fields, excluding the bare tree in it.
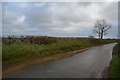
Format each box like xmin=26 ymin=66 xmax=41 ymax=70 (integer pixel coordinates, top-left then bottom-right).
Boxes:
xmin=2 ymin=2 xmax=118 ymax=38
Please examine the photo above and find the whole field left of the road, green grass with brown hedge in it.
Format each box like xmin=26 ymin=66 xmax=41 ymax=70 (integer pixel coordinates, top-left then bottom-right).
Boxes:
xmin=2 ymin=36 xmax=115 ymax=65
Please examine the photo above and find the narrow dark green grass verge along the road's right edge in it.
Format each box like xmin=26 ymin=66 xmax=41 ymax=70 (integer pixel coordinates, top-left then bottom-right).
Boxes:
xmin=109 ymin=42 xmax=120 ymax=78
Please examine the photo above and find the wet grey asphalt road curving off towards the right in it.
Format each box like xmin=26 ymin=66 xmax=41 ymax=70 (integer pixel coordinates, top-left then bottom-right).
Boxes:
xmin=6 ymin=43 xmax=116 ymax=78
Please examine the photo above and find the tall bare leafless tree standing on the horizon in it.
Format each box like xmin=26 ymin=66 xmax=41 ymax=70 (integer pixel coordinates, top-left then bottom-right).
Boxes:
xmin=93 ymin=19 xmax=112 ymax=39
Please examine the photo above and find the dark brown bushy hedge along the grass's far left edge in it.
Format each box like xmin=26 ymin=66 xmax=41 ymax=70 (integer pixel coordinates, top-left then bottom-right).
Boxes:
xmin=2 ymin=36 xmax=57 ymax=45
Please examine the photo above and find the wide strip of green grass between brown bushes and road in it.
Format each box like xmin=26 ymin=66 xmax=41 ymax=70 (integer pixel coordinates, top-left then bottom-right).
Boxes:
xmin=2 ymin=39 xmax=114 ymax=65
